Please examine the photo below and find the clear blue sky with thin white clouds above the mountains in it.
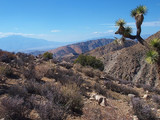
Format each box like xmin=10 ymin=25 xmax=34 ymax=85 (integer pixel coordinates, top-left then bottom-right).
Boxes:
xmin=0 ymin=0 xmax=160 ymax=42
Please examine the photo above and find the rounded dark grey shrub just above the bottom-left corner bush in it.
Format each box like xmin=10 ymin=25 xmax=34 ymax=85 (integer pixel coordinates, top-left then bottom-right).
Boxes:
xmin=8 ymin=85 xmax=28 ymax=98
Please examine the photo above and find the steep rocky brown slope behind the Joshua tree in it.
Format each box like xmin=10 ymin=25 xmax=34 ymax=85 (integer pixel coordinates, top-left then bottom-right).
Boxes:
xmin=89 ymin=31 xmax=160 ymax=86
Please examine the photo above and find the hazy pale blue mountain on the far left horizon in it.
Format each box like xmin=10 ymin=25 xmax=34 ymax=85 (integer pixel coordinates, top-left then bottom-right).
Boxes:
xmin=0 ymin=35 xmax=67 ymax=52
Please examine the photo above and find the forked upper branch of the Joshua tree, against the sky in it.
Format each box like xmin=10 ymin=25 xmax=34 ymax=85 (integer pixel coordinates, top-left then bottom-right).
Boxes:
xmin=115 ymin=5 xmax=147 ymax=45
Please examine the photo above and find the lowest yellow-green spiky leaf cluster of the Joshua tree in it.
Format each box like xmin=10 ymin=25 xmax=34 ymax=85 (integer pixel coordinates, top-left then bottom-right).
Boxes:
xmin=145 ymin=50 xmax=159 ymax=64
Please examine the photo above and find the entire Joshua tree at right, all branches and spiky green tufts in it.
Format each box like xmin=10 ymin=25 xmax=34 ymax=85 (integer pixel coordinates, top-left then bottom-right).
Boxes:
xmin=115 ymin=5 xmax=160 ymax=85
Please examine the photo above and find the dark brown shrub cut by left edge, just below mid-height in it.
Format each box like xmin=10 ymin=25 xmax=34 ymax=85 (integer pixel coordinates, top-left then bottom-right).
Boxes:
xmin=0 ymin=66 xmax=13 ymax=77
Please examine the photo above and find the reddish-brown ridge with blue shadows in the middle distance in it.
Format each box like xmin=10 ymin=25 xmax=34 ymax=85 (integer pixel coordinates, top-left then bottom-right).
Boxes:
xmin=49 ymin=38 xmax=113 ymax=60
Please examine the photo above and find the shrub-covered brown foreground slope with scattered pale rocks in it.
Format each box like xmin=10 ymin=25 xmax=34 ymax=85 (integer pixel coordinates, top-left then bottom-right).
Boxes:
xmin=0 ymin=51 xmax=160 ymax=120
